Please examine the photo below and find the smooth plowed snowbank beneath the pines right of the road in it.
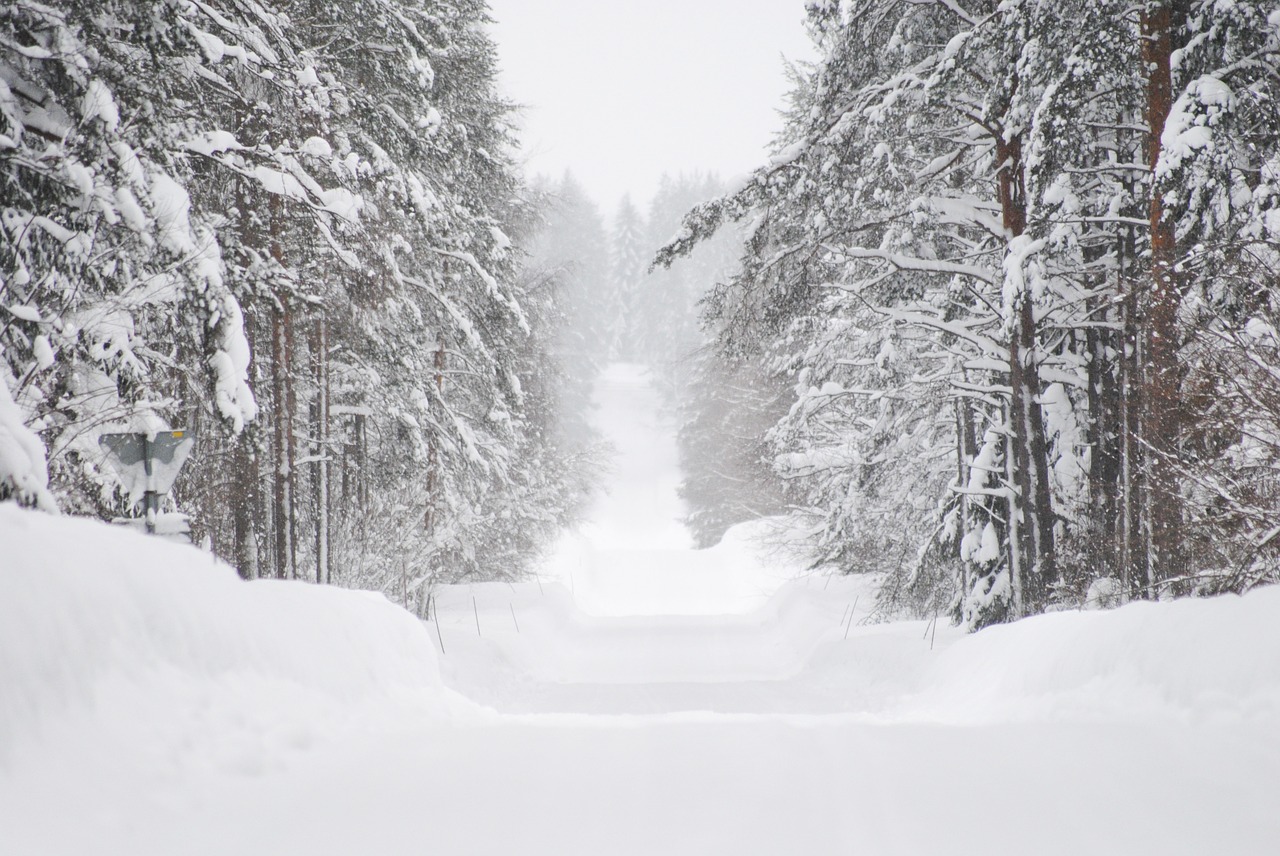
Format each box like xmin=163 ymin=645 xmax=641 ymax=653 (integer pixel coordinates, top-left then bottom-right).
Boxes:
xmin=904 ymin=586 xmax=1280 ymax=723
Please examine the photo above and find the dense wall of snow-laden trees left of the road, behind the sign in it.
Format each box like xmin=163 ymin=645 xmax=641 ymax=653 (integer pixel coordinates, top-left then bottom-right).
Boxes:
xmin=0 ymin=0 xmax=586 ymax=603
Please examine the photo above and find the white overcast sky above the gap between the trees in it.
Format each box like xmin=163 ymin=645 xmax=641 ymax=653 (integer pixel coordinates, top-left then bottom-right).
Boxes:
xmin=489 ymin=0 xmax=814 ymax=215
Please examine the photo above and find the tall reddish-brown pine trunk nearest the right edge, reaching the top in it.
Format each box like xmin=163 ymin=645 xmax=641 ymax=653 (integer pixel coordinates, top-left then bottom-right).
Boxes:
xmin=1142 ymin=0 xmax=1184 ymax=595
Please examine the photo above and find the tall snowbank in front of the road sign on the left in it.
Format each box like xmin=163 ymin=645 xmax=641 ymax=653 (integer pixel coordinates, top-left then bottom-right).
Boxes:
xmin=0 ymin=504 xmax=443 ymax=772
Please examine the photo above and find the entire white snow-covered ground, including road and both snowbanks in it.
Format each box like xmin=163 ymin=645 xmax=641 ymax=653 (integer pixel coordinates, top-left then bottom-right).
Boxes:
xmin=0 ymin=367 xmax=1280 ymax=856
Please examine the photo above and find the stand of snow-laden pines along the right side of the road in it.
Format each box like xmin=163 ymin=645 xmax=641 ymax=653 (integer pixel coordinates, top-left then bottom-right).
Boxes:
xmin=659 ymin=0 xmax=1280 ymax=626
